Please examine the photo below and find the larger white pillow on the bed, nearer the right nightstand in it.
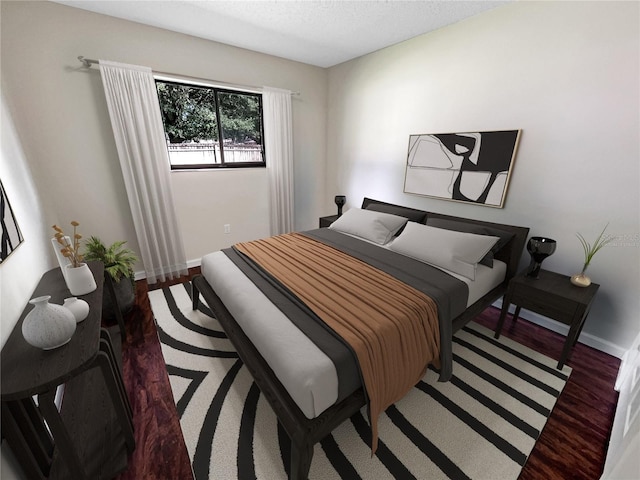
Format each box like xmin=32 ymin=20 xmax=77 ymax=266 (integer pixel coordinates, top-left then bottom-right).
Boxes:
xmin=389 ymin=222 xmax=500 ymax=280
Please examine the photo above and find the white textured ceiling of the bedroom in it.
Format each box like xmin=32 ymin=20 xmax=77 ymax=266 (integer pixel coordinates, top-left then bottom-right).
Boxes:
xmin=53 ymin=0 xmax=509 ymax=67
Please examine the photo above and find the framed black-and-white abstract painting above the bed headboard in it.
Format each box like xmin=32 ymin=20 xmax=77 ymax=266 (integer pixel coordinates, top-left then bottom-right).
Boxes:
xmin=404 ymin=130 xmax=521 ymax=208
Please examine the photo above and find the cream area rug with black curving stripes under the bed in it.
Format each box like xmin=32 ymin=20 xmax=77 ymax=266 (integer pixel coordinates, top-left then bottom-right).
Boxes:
xmin=149 ymin=283 xmax=571 ymax=480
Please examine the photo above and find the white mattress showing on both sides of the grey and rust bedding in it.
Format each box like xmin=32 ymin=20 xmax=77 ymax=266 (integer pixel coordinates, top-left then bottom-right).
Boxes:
xmin=202 ymin=246 xmax=507 ymax=418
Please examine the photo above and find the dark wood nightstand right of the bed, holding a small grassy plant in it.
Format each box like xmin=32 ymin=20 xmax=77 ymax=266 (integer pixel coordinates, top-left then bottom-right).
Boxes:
xmin=495 ymin=270 xmax=600 ymax=368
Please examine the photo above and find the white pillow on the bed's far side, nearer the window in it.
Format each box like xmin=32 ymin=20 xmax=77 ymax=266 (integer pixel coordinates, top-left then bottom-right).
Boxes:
xmin=329 ymin=208 xmax=408 ymax=245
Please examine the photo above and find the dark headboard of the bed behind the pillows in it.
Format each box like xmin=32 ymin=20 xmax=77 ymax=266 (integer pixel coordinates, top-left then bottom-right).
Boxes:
xmin=362 ymin=197 xmax=529 ymax=284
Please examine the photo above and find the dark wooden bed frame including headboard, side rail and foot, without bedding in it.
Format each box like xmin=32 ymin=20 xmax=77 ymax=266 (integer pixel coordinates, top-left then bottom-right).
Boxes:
xmin=192 ymin=198 xmax=529 ymax=480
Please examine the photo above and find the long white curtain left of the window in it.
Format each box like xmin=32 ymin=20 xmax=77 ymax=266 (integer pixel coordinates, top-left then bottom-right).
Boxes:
xmin=99 ymin=60 xmax=188 ymax=283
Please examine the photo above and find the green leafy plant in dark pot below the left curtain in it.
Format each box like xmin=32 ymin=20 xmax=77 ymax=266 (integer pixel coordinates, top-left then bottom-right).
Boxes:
xmin=84 ymin=236 xmax=138 ymax=320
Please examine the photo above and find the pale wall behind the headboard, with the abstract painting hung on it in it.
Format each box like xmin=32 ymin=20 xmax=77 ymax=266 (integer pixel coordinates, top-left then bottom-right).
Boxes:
xmin=325 ymin=2 xmax=640 ymax=354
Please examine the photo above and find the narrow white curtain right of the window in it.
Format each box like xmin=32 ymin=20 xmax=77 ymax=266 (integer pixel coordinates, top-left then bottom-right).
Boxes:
xmin=262 ymin=87 xmax=293 ymax=235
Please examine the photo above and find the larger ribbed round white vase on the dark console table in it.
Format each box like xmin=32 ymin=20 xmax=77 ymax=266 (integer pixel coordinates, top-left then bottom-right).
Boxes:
xmin=22 ymin=295 xmax=76 ymax=350
